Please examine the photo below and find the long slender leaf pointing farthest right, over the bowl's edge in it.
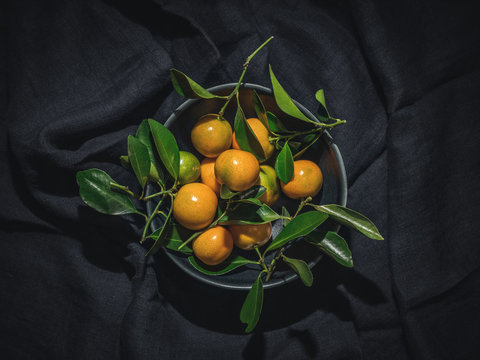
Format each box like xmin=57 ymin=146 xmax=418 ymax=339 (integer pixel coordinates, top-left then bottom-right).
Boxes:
xmin=309 ymin=204 xmax=383 ymax=240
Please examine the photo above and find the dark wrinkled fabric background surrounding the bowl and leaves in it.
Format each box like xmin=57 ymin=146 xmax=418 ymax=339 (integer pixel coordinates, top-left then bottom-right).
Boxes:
xmin=0 ymin=0 xmax=480 ymax=359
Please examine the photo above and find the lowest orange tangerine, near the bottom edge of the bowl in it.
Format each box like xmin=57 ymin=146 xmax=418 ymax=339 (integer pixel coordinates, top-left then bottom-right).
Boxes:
xmin=192 ymin=226 xmax=233 ymax=265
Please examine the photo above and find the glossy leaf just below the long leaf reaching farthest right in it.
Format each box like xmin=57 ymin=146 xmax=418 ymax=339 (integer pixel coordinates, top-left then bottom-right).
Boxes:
xmin=305 ymin=231 xmax=353 ymax=267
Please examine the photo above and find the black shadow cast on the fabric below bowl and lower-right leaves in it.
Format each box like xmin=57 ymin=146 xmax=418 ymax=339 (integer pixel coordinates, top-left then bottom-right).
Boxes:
xmin=154 ymin=249 xmax=386 ymax=336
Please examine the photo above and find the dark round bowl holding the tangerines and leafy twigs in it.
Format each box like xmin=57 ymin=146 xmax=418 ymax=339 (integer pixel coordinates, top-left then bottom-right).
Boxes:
xmin=147 ymin=83 xmax=347 ymax=290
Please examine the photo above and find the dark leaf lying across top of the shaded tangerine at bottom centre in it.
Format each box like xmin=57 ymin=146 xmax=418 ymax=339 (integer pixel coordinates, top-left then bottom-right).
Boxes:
xmin=218 ymin=203 xmax=280 ymax=225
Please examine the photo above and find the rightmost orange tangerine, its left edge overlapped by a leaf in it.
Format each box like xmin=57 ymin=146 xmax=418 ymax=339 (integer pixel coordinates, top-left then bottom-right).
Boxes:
xmin=280 ymin=160 xmax=323 ymax=199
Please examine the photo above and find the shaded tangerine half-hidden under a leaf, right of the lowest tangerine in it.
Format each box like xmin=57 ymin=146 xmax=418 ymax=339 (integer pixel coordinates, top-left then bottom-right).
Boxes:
xmin=228 ymin=223 xmax=272 ymax=250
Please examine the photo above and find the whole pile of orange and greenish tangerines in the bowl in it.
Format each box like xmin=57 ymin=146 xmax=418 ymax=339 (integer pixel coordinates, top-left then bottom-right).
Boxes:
xmin=173 ymin=114 xmax=323 ymax=265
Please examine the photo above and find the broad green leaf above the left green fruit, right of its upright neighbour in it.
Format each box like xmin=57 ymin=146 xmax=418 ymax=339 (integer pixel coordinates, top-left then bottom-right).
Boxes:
xmin=148 ymin=119 xmax=180 ymax=180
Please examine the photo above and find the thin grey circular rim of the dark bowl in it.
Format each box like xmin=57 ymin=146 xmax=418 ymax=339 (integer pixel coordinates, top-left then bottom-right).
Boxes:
xmin=156 ymin=83 xmax=348 ymax=290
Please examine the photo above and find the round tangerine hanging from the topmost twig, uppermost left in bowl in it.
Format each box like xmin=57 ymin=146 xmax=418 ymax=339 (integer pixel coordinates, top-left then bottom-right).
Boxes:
xmin=190 ymin=114 xmax=232 ymax=157
